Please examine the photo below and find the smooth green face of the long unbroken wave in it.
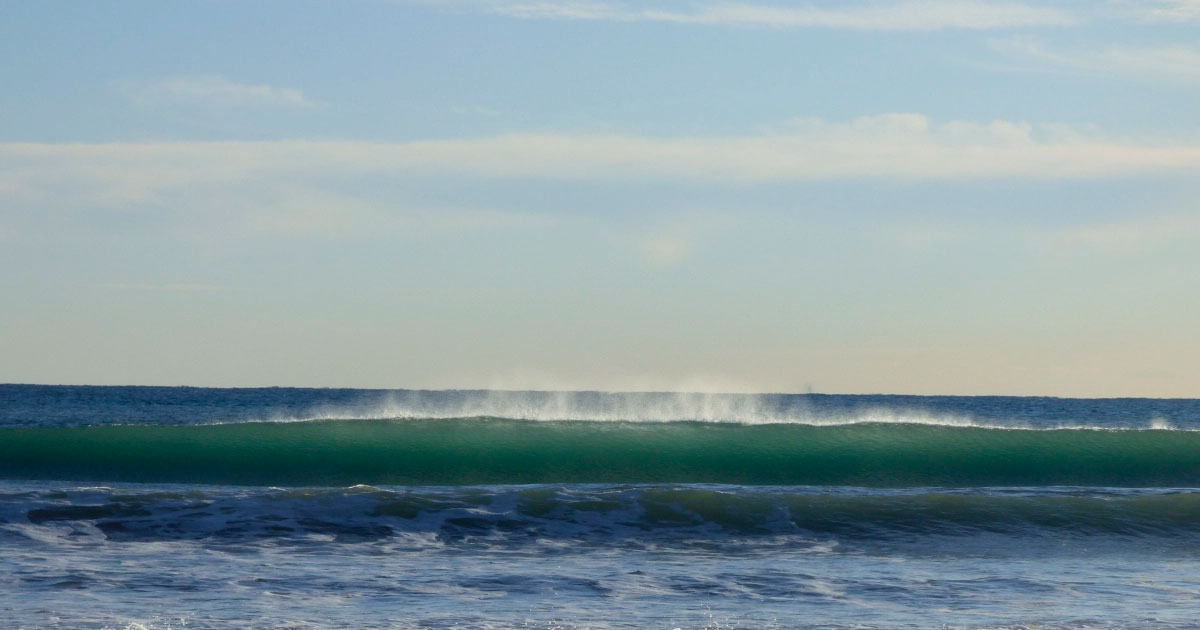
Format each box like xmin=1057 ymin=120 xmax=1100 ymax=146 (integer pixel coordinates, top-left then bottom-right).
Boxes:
xmin=0 ymin=419 xmax=1200 ymax=487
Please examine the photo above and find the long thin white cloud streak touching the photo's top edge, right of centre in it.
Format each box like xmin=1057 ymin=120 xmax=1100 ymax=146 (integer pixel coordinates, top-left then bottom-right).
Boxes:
xmin=425 ymin=0 xmax=1080 ymax=31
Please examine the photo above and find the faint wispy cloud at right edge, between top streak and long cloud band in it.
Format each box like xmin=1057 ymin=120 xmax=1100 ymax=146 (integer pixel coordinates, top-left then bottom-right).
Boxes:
xmin=991 ymin=37 xmax=1200 ymax=83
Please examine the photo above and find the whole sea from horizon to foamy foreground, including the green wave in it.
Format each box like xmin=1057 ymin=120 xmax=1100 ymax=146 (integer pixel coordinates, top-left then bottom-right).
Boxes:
xmin=0 ymin=385 xmax=1200 ymax=630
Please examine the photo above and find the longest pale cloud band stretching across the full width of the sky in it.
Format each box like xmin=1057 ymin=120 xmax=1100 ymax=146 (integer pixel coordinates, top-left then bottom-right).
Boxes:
xmin=0 ymin=114 xmax=1200 ymax=204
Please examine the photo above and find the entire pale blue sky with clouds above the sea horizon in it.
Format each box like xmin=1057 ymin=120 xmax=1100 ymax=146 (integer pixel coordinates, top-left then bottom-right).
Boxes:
xmin=0 ymin=0 xmax=1200 ymax=397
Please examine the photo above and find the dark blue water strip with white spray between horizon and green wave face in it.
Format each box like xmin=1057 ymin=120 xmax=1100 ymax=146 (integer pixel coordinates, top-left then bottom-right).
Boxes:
xmin=7 ymin=385 xmax=1200 ymax=428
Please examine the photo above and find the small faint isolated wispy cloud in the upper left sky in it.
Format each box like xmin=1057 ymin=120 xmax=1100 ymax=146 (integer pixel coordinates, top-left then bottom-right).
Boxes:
xmin=120 ymin=74 xmax=324 ymax=108
